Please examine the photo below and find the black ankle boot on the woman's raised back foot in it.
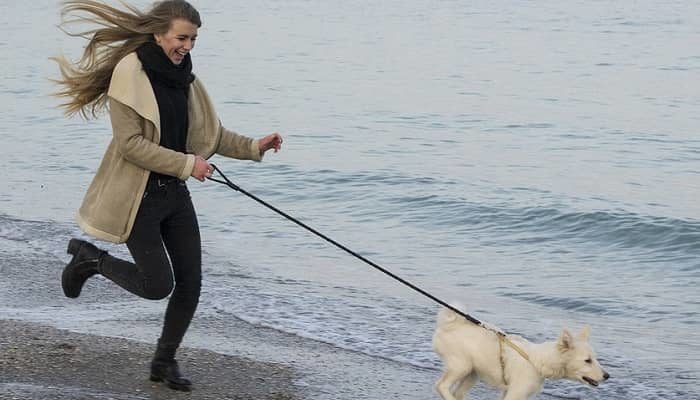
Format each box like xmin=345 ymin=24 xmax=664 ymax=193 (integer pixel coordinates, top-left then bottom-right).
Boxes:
xmin=61 ymin=239 xmax=107 ymax=298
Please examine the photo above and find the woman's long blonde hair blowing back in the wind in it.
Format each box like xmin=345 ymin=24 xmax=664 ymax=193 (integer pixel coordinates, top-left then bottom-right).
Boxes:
xmin=52 ymin=0 xmax=202 ymax=119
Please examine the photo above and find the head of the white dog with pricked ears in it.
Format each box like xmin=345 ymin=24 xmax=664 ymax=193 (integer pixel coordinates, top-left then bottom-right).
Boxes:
xmin=557 ymin=326 xmax=610 ymax=386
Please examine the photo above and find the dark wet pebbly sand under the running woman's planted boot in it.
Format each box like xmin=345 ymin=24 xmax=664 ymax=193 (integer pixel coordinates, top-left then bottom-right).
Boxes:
xmin=0 ymin=320 xmax=303 ymax=400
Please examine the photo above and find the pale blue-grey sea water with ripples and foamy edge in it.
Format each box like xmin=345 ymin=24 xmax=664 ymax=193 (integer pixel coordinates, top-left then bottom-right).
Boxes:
xmin=0 ymin=0 xmax=700 ymax=400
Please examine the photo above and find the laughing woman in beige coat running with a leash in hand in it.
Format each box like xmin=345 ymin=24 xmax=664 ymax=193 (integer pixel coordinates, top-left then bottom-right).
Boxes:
xmin=56 ymin=0 xmax=282 ymax=391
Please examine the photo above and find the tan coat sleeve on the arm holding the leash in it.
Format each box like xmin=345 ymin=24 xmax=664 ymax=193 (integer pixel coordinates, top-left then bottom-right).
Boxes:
xmin=109 ymin=98 xmax=195 ymax=180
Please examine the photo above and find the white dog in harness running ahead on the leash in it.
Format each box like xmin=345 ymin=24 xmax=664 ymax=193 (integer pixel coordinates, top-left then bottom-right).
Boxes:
xmin=433 ymin=308 xmax=610 ymax=400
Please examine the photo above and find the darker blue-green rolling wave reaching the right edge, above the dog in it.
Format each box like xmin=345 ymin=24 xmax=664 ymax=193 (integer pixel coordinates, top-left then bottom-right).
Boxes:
xmin=388 ymin=194 xmax=700 ymax=258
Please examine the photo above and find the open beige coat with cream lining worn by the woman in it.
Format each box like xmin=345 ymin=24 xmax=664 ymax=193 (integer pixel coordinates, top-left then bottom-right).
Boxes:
xmin=77 ymin=53 xmax=262 ymax=243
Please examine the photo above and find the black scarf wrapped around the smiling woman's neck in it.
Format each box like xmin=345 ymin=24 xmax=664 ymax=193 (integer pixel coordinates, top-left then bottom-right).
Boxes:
xmin=136 ymin=42 xmax=194 ymax=89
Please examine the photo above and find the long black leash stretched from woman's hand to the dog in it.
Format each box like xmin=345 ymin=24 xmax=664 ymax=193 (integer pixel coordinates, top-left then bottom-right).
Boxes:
xmin=207 ymin=163 xmax=494 ymax=337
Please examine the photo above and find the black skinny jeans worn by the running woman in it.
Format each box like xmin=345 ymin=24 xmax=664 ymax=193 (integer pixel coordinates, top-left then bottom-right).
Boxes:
xmin=100 ymin=174 xmax=202 ymax=349
